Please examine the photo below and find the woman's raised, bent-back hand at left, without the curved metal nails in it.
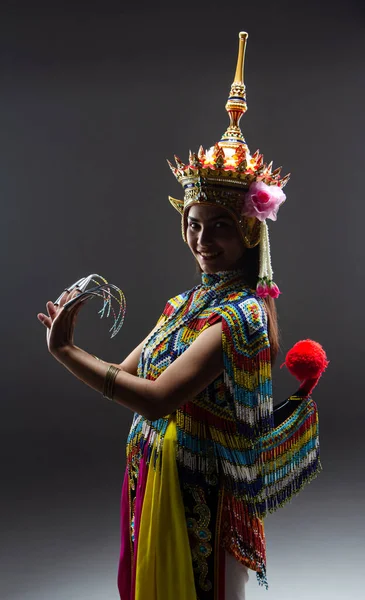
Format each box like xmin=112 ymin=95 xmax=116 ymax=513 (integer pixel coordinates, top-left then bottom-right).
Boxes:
xmin=37 ymin=288 xmax=86 ymax=358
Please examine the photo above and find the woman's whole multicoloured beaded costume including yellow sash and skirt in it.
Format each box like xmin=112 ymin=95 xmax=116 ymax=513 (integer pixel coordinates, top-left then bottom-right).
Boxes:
xmin=119 ymin=271 xmax=321 ymax=600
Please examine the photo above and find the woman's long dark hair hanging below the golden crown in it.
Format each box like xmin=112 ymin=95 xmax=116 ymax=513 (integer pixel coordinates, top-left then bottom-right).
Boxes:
xmin=196 ymin=244 xmax=280 ymax=366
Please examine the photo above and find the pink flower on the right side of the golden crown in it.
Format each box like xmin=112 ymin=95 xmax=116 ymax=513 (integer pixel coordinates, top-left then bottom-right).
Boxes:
xmin=242 ymin=181 xmax=286 ymax=221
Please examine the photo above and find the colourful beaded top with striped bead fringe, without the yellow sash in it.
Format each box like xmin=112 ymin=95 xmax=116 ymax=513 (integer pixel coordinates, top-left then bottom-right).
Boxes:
xmin=121 ymin=271 xmax=321 ymax=600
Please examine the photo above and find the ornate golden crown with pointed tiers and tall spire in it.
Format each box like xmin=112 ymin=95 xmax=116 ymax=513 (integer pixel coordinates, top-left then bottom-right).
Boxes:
xmin=168 ymin=32 xmax=290 ymax=214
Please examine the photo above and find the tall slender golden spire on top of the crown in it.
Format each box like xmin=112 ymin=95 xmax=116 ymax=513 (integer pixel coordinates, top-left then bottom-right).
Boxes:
xmin=219 ymin=31 xmax=248 ymax=148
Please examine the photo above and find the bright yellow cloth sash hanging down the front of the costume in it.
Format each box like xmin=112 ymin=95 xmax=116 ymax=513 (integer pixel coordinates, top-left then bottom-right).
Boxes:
xmin=135 ymin=416 xmax=196 ymax=600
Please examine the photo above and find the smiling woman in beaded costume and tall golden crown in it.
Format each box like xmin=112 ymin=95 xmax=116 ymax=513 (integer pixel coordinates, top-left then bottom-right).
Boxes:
xmin=38 ymin=34 xmax=320 ymax=600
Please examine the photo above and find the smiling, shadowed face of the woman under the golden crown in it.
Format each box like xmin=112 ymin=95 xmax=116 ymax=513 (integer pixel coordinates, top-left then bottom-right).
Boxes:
xmin=186 ymin=204 xmax=245 ymax=273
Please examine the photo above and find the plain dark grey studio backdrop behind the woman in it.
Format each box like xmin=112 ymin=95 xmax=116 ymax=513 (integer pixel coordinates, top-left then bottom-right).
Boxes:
xmin=0 ymin=0 xmax=365 ymax=600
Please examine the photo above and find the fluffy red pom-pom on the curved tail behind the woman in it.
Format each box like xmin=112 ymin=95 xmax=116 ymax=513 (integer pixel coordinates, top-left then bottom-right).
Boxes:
xmin=280 ymin=340 xmax=329 ymax=395
